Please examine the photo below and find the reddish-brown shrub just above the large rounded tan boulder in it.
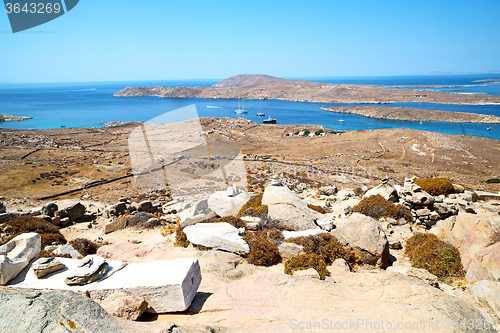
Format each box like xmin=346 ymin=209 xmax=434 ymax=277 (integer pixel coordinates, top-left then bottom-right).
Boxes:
xmin=352 ymin=194 xmax=412 ymax=222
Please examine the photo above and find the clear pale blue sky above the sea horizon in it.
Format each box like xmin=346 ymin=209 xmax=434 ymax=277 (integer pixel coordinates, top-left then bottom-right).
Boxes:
xmin=0 ymin=0 xmax=500 ymax=82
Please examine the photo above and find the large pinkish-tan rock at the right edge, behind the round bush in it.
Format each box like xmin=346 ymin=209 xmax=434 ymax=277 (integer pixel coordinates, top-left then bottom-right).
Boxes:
xmin=431 ymin=212 xmax=500 ymax=282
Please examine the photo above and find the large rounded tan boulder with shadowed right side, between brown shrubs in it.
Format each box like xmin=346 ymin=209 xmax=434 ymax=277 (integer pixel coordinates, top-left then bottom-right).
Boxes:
xmin=331 ymin=213 xmax=389 ymax=268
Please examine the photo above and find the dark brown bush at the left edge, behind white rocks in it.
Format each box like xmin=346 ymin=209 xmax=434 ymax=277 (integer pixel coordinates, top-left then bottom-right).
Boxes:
xmin=0 ymin=215 xmax=67 ymax=249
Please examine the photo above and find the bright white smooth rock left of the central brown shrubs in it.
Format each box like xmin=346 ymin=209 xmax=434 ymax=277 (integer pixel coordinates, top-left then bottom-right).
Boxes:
xmin=184 ymin=222 xmax=250 ymax=253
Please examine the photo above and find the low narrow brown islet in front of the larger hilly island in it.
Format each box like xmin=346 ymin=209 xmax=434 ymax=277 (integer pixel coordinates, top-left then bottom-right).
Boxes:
xmin=321 ymin=106 xmax=500 ymax=124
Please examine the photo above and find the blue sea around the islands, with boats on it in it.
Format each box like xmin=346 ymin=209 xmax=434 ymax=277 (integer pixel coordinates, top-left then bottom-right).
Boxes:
xmin=0 ymin=74 xmax=500 ymax=139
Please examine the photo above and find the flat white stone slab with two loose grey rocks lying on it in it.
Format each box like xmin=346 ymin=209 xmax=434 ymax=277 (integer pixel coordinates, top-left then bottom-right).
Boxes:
xmin=6 ymin=255 xmax=127 ymax=294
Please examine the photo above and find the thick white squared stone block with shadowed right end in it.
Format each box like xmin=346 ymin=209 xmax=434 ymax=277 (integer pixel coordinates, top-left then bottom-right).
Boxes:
xmin=89 ymin=258 xmax=201 ymax=313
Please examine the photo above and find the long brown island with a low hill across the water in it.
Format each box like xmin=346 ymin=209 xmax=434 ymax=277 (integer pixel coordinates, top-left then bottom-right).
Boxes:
xmin=114 ymin=75 xmax=500 ymax=105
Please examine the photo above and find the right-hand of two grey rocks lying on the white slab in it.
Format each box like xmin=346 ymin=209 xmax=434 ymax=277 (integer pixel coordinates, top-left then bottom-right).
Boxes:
xmin=65 ymin=256 xmax=109 ymax=286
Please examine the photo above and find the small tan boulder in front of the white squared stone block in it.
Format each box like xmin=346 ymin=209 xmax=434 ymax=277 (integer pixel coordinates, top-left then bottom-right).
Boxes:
xmin=100 ymin=292 xmax=148 ymax=320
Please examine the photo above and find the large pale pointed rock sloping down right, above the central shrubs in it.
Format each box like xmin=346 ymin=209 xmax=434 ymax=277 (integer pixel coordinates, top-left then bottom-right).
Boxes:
xmin=262 ymin=185 xmax=324 ymax=230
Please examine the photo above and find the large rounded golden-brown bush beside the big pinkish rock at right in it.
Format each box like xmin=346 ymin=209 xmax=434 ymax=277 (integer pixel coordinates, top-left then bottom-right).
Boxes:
xmin=405 ymin=233 xmax=465 ymax=282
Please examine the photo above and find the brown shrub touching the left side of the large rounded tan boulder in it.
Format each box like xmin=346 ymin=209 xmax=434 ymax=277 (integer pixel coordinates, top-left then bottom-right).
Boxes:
xmin=286 ymin=233 xmax=357 ymax=264
